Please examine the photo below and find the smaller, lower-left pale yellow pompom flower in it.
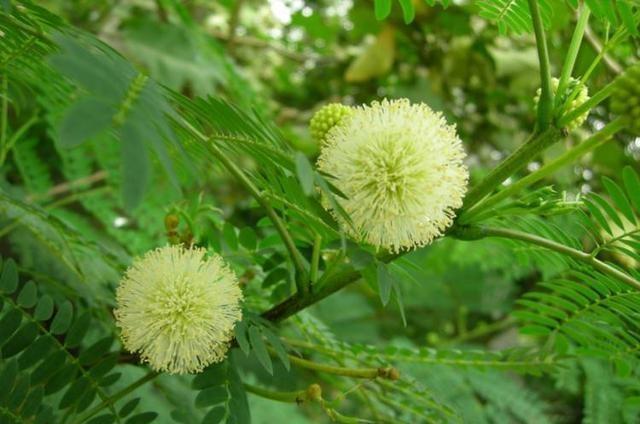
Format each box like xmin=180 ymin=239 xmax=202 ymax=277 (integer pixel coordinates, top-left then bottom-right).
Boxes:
xmin=114 ymin=246 xmax=242 ymax=374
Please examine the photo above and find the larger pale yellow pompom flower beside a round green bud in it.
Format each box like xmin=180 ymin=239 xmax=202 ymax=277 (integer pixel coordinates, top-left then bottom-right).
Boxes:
xmin=318 ymin=99 xmax=469 ymax=252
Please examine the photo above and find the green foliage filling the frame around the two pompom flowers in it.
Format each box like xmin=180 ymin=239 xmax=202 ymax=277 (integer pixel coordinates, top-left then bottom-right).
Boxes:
xmin=0 ymin=0 xmax=640 ymax=423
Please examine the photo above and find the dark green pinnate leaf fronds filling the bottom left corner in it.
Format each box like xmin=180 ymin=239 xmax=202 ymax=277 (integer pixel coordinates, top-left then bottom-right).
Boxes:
xmin=0 ymin=259 xmax=156 ymax=423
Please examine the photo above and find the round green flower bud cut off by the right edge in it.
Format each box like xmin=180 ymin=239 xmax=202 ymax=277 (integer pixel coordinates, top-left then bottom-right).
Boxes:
xmin=611 ymin=65 xmax=640 ymax=134
